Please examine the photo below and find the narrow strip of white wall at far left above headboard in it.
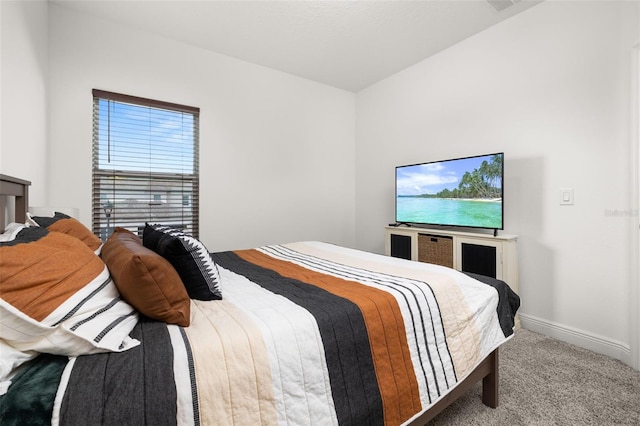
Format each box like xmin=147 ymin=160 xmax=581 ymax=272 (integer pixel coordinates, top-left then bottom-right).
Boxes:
xmin=0 ymin=1 xmax=49 ymax=204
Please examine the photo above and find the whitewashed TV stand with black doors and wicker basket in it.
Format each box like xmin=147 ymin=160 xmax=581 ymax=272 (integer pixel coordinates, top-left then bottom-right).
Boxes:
xmin=385 ymin=225 xmax=518 ymax=293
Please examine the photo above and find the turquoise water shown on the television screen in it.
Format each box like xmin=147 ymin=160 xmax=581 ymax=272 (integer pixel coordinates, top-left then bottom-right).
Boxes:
xmin=396 ymin=197 xmax=502 ymax=229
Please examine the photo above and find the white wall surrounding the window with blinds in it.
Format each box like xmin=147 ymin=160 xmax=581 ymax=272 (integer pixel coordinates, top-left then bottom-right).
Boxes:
xmin=49 ymin=4 xmax=355 ymax=251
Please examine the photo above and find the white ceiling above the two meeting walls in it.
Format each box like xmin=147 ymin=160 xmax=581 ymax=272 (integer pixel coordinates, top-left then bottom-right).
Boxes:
xmin=49 ymin=0 xmax=541 ymax=92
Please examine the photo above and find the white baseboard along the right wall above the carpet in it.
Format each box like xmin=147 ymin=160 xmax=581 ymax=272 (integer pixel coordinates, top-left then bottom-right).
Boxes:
xmin=518 ymin=314 xmax=633 ymax=367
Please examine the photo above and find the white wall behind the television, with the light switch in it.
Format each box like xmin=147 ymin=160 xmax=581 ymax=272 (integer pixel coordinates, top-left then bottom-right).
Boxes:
xmin=356 ymin=1 xmax=640 ymax=362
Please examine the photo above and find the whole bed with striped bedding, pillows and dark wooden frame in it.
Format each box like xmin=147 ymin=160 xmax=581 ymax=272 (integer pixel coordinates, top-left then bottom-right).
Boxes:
xmin=0 ymin=176 xmax=519 ymax=425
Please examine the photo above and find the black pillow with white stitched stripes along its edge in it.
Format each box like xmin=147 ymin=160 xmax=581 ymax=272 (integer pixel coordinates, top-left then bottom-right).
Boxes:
xmin=142 ymin=223 xmax=222 ymax=300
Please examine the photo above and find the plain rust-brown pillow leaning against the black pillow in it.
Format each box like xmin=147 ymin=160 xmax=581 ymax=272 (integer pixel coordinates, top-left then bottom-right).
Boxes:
xmin=102 ymin=228 xmax=191 ymax=327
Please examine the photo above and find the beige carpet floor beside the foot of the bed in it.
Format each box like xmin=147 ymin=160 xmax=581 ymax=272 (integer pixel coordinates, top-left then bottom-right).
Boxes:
xmin=429 ymin=330 xmax=640 ymax=426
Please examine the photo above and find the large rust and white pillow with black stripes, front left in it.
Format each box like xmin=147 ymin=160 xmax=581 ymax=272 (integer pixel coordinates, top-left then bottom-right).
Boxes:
xmin=0 ymin=227 xmax=139 ymax=362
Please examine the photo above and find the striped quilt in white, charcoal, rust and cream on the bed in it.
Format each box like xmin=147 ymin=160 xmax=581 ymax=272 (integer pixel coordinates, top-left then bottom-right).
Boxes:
xmin=3 ymin=242 xmax=517 ymax=425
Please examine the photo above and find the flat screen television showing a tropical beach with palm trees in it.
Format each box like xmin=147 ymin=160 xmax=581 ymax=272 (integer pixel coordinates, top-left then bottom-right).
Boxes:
xmin=396 ymin=153 xmax=504 ymax=230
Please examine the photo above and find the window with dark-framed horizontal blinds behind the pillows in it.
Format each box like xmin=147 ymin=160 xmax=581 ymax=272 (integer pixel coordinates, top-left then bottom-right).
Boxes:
xmin=92 ymin=90 xmax=200 ymax=240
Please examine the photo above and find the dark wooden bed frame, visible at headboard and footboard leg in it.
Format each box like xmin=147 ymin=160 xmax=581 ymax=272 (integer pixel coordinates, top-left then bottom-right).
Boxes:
xmin=0 ymin=174 xmax=498 ymax=426
